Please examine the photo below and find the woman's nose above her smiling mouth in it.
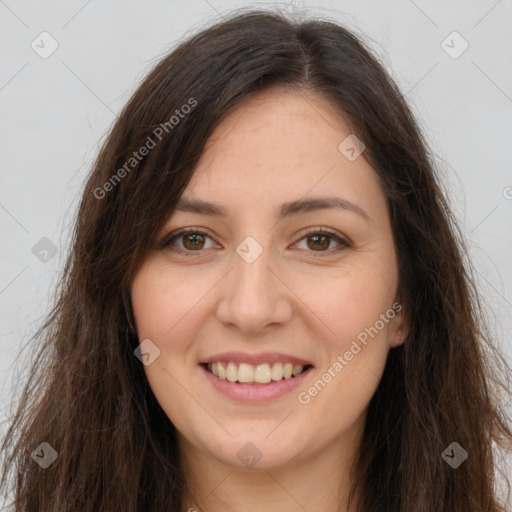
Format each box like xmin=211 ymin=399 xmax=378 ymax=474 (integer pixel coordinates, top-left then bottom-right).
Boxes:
xmin=216 ymin=242 xmax=293 ymax=334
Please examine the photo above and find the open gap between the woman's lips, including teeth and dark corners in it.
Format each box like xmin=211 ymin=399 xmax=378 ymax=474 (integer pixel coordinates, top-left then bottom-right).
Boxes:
xmin=200 ymin=361 xmax=313 ymax=386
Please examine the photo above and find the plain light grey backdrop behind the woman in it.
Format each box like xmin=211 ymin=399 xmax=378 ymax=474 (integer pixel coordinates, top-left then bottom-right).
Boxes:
xmin=0 ymin=0 xmax=512 ymax=502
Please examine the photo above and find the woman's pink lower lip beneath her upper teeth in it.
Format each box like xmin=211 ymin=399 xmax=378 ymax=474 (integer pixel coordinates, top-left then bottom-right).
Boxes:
xmin=199 ymin=365 xmax=313 ymax=403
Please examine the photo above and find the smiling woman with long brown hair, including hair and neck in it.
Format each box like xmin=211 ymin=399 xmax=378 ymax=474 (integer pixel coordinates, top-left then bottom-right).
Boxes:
xmin=4 ymin=11 xmax=512 ymax=512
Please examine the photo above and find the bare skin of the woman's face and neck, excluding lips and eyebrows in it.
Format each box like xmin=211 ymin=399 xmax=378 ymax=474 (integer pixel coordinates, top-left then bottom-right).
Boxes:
xmin=132 ymin=88 xmax=407 ymax=512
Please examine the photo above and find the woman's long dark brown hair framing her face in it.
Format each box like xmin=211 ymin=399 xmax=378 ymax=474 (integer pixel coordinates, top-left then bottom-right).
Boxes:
xmin=2 ymin=11 xmax=512 ymax=512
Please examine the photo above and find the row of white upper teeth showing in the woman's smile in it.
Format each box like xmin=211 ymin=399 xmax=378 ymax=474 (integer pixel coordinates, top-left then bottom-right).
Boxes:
xmin=207 ymin=361 xmax=304 ymax=384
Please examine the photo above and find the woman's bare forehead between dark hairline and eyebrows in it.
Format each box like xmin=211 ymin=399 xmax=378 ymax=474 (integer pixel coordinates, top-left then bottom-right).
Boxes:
xmin=184 ymin=88 xmax=382 ymax=215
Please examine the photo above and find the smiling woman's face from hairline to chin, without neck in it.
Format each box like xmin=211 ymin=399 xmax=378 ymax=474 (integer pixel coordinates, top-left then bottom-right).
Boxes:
xmin=132 ymin=89 xmax=405 ymax=468
